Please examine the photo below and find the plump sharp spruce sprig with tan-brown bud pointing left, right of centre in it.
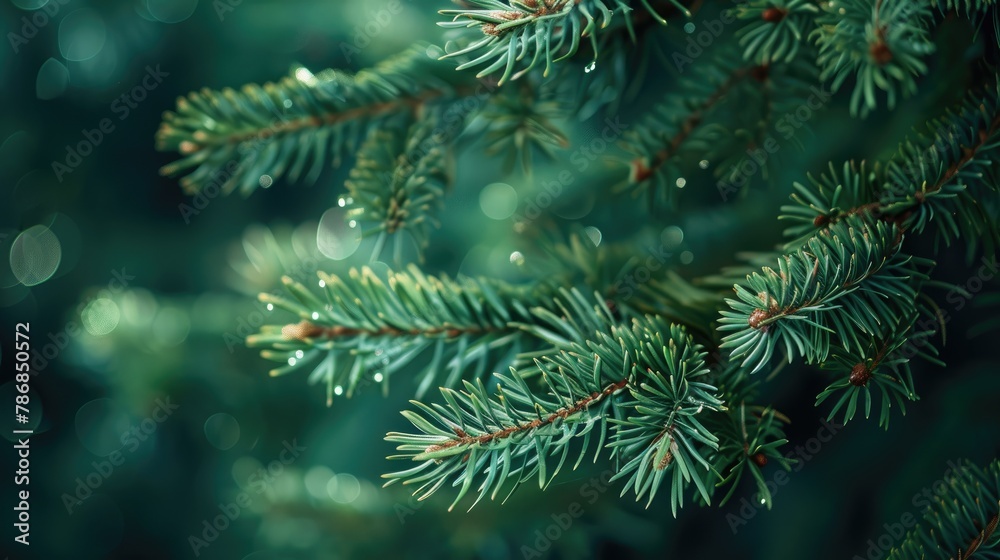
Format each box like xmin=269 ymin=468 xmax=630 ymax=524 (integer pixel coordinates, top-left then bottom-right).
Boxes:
xmin=719 ymin=217 xmax=925 ymax=372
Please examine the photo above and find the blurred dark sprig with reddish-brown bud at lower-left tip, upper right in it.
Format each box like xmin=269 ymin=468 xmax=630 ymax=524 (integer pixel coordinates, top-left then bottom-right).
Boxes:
xmin=616 ymin=39 xmax=817 ymax=207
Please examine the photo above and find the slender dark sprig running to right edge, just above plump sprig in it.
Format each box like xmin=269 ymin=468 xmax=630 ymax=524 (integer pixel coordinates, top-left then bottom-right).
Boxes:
xmin=781 ymin=79 xmax=1000 ymax=259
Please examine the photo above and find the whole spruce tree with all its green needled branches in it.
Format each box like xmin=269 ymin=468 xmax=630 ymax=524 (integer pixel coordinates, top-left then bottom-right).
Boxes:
xmin=157 ymin=0 xmax=1000 ymax=558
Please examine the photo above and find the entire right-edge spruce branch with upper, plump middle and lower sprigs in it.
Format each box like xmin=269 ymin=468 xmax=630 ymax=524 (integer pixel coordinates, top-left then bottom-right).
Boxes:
xmin=719 ymin=81 xmax=1000 ymax=427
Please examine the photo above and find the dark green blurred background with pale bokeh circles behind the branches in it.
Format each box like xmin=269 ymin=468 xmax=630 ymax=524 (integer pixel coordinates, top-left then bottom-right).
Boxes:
xmin=0 ymin=0 xmax=1000 ymax=560
